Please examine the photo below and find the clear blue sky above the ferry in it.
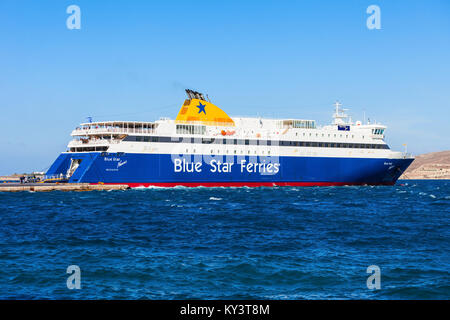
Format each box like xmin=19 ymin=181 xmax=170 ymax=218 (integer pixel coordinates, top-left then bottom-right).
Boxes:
xmin=0 ymin=0 xmax=450 ymax=175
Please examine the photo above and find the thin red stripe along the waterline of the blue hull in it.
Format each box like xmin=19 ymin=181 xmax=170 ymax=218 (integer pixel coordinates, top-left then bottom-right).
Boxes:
xmin=97 ymin=182 xmax=395 ymax=188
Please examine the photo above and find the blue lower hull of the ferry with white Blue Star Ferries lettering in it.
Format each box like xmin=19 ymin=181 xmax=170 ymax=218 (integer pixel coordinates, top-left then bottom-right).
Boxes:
xmin=47 ymin=152 xmax=413 ymax=187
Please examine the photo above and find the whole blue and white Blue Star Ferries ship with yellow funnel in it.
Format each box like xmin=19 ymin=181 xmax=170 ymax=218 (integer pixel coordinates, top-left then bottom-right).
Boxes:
xmin=46 ymin=90 xmax=414 ymax=187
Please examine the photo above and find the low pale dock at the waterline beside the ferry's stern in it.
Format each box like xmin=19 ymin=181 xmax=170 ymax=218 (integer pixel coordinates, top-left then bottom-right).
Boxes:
xmin=0 ymin=183 xmax=130 ymax=192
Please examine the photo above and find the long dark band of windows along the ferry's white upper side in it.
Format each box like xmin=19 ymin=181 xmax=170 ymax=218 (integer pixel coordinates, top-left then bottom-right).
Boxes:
xmin=124 ymin=136 xmax=389 ymax=149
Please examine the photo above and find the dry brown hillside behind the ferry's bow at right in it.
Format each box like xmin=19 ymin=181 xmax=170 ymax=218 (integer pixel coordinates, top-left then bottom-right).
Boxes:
xmin=400 ymin=150 xmax=450 ymax=179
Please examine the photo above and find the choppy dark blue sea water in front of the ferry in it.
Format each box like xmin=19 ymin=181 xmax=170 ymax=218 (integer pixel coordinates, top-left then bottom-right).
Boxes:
xmin=0 ymin=181 xmax=450 ymax=299
